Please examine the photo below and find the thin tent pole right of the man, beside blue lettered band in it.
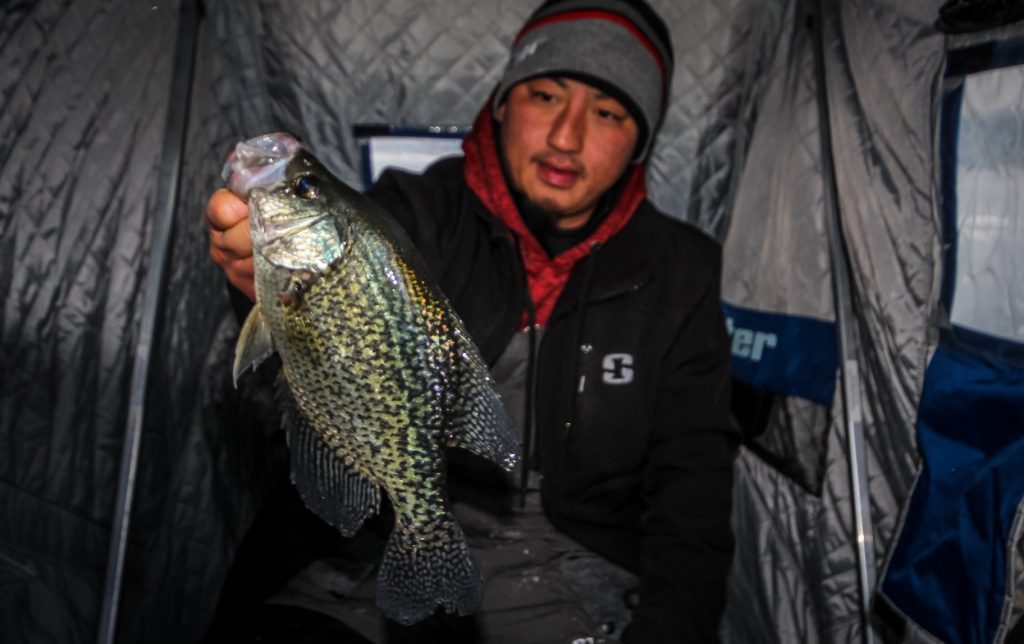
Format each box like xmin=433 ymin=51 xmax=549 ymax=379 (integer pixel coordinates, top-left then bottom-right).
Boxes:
xmin=811 ymin=0 xmax=876 ymax=644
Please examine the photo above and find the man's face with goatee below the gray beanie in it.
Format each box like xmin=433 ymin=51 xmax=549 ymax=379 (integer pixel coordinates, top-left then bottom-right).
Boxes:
xmin=498 ymin=77 xmax=638 ymax=229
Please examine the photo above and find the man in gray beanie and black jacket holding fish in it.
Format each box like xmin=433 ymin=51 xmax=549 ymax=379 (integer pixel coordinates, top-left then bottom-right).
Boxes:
xmin=208 ymin=0 xmax=738 ymax=643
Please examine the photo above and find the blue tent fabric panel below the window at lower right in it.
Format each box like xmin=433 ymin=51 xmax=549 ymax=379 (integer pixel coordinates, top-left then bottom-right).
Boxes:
xmin=883 ymin=347 xmax=1024 ymax=643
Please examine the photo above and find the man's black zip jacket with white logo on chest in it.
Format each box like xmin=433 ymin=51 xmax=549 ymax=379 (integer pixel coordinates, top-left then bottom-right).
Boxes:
xmin=369 ymin=159 xmax=738 ymax=643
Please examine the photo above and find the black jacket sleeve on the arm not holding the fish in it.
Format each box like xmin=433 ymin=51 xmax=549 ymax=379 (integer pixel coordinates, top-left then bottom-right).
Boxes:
xmin=623 ymin=242 xmax=739 ymax=644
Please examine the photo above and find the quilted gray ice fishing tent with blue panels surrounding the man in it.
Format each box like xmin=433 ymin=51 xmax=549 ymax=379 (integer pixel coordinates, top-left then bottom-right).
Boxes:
xmin=0 ymin=0 xmax=1024 ymax=642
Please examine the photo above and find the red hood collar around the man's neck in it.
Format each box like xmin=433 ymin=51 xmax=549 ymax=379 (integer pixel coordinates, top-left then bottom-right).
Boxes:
xmin=463 ymin=106 xmax=647 ymax=326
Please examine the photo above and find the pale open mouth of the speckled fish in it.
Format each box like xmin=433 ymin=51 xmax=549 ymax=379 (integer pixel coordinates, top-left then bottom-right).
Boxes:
xmin=220 ymin=132 xmax=301 ymax=199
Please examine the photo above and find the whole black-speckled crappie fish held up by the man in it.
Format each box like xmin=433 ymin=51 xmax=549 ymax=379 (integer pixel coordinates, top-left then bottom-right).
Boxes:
xmin=225 ymin=133 xmax=518 ymax=624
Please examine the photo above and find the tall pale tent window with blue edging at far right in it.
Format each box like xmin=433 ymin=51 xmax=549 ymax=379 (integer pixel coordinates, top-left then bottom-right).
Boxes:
xmin=941 ymin=41 xmax=1024 ymax=352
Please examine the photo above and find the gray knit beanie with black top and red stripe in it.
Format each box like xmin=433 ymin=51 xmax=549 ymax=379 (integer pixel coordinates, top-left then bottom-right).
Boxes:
xmin=494 ymin=0 xmax=673 ymax=161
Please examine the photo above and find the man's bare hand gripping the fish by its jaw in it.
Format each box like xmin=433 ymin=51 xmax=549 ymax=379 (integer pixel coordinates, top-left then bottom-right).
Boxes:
xmin=206 ymin=188 xmax=256 ymax=301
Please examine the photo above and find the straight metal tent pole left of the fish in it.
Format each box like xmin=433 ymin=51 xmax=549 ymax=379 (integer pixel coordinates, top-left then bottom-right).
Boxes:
xmin=96 ymin=0 xmax=199 ymax=644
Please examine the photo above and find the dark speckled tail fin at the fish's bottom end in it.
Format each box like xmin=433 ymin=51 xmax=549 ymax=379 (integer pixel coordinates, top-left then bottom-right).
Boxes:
xmin=377 ymin=518 xmax=482 ymax=625
